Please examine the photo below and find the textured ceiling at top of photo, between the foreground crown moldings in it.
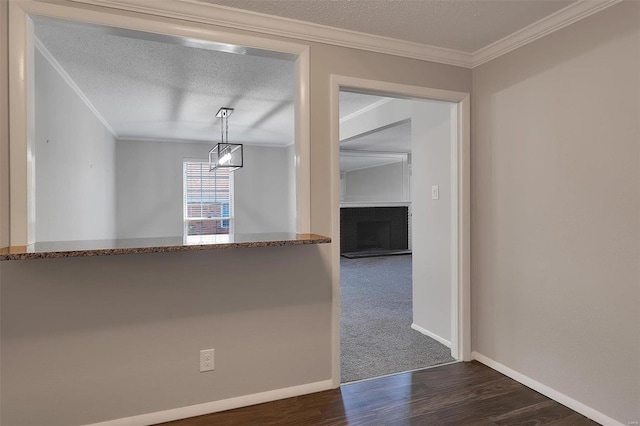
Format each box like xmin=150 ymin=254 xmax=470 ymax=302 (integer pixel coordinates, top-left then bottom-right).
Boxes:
xmin=202 ymin=0 xmax=576 ymax=53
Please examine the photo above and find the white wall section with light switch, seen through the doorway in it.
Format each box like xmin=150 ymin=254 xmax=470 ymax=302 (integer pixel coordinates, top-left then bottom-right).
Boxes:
xmin=411 ymin=101 xmax=453 ymax=341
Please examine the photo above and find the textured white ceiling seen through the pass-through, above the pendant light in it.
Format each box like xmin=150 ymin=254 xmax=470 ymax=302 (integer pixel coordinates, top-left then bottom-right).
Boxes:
xmin=35 ymin=20 xmax=295 ymax=146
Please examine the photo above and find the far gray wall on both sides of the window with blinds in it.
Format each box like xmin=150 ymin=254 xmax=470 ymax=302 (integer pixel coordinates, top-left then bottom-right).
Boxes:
xmin=116 ymin=140 xmax=295 ymax=238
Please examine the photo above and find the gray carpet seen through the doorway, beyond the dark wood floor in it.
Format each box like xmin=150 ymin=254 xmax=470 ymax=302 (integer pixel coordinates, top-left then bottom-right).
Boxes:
xmin=340 ymin=255 xmax=454 ymax=383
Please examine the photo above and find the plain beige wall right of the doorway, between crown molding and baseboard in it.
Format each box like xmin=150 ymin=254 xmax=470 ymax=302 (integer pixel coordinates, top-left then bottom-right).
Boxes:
xmin=471 ymin=2 xmax=640 ymax=424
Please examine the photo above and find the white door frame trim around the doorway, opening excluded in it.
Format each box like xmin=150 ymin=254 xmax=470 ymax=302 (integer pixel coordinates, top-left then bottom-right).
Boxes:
xmin=330 ymin=74 xmax=471 ymax=387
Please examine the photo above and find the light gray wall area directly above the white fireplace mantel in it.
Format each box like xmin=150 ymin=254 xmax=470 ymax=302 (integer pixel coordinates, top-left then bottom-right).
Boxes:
xmin=344 ymin=162 xmax=408 ymax=202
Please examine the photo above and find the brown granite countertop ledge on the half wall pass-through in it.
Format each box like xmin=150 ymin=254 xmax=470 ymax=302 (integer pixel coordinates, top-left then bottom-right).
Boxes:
xmin=0 ymin=232 xmax=331 ymax=261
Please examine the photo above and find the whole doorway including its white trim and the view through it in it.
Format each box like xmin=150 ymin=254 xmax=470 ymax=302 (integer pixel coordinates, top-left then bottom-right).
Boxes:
xmin=332 ymin=76 xmax=470 ymax=383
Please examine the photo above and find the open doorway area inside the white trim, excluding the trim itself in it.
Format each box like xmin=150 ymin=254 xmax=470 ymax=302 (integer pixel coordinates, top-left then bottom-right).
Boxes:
xmin=340 ymin=91 xmax=455 ymax=382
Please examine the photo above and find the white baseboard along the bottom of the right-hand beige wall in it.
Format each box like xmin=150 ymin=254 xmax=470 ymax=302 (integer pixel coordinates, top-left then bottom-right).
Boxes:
xmin=471 ymin=351 xmax=625 ymax=426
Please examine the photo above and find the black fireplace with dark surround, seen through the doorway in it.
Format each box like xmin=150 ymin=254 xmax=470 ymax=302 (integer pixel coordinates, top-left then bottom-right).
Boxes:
xmin=340 ymin=207 xmax=409 ymax=253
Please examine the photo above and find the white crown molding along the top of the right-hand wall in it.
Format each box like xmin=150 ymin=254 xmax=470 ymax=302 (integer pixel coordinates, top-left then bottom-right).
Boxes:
xmin=471 ymin=0 xmax=622 ymax=68
